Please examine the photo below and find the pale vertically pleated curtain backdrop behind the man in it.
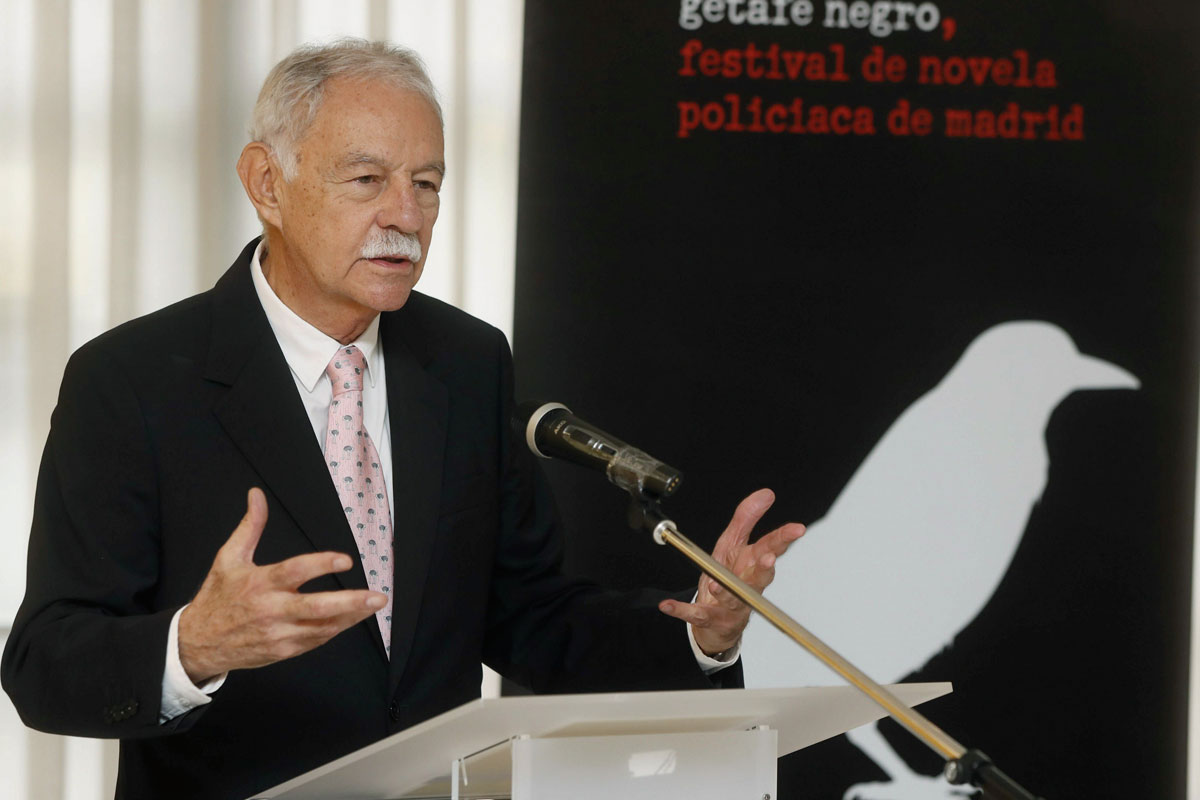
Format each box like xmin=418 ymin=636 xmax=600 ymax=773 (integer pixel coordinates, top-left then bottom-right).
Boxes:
xmin=0 ymin=0 xmax=523 ymax=800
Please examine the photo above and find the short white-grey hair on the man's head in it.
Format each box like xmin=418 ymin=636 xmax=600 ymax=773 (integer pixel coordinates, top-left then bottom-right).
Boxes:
xmin=250 ymin=37 xmax=445 ymax=180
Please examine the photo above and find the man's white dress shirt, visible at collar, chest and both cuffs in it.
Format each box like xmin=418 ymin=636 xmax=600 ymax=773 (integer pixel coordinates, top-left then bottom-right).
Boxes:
xmin=158 ymin=240 xmax=740 ymax=722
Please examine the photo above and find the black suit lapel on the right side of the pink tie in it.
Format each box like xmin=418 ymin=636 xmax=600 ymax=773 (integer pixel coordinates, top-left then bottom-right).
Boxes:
xmin=379 ymin=309 xmax=448 ymax=684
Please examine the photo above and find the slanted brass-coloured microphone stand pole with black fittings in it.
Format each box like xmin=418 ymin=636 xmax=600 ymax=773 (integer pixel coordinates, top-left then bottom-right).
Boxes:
xmin=629 ymin=491 xmax=1040 ymax=800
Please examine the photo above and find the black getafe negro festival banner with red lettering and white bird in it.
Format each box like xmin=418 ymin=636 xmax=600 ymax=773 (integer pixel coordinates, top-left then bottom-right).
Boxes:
xmin=515 ymin=0 xmax=1200 ymax=799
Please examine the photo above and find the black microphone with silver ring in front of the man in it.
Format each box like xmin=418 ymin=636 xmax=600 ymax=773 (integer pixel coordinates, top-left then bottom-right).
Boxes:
xmin=512 ymin=402 xmax=683 ymax=498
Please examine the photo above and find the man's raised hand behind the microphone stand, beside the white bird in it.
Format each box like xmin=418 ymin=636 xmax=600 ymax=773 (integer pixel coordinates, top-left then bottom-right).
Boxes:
xmin=659 ymin=489 xmax=804 ymax=656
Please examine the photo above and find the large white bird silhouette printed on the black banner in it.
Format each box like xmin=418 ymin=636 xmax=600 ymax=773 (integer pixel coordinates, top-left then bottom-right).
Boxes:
xmin=743 ymin=321 xmax=1140 ymax=800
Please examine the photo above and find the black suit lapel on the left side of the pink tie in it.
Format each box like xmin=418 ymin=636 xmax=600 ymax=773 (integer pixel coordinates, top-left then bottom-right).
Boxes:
xmin=205 ymin=242 xmax=372 ymax=614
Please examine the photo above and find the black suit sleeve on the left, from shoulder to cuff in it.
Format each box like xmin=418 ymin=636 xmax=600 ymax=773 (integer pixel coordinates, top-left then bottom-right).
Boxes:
xmin=2 ymin=348 xmax=184 ymax=738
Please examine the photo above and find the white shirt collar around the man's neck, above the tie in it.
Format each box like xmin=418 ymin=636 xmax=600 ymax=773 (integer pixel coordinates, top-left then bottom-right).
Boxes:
xmin=250 ymin=239 xmax=383 ymax=392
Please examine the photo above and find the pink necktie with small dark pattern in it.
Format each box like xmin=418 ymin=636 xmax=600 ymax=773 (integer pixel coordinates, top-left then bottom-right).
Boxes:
xmin=325 ymin=345 xmax=392 ymax=657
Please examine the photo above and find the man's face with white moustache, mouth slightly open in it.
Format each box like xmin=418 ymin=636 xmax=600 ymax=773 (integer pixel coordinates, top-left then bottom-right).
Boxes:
xmin=266 ymin=79 xmax=445 ymax=338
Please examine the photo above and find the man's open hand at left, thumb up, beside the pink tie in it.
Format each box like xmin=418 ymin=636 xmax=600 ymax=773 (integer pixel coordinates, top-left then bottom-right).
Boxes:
xmin=179 ymin=488 xmax=388 ymax=684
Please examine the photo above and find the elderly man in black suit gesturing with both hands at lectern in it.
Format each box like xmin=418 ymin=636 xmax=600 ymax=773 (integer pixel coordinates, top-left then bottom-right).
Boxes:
xmin=4 ymin=41 xmax=802 ymax=799
